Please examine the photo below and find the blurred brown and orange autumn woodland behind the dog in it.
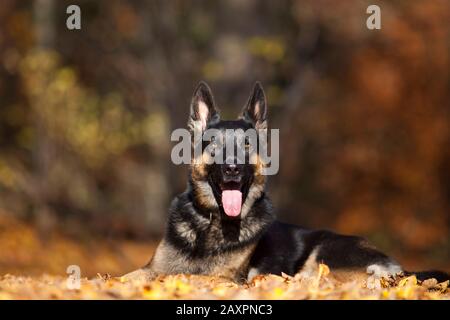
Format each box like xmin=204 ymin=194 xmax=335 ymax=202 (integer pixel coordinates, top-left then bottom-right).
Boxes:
xmin=0 ymin=0 xmax=450 ymax=276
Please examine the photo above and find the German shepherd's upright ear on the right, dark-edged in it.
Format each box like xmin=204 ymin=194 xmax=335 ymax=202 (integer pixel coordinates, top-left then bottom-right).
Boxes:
xmin=241 ymin=81 xmax=267 ymax=129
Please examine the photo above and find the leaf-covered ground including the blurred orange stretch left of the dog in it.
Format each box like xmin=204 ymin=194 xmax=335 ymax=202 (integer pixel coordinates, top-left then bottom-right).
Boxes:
xmin=0 ymin=216 xmax=450 ymax=299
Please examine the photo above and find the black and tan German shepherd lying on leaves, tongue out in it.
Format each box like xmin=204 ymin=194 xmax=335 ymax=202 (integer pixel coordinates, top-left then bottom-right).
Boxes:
xmin=124 ymin=82 xmax=450 ymax=287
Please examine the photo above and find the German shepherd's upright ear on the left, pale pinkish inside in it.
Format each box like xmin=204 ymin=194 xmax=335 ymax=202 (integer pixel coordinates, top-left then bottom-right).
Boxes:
xmin=188 ymin=81 xmax=219 ymax=131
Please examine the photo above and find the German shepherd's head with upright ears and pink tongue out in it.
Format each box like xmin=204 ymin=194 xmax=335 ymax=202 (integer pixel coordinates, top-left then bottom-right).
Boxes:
xmin=188 ymin=82 xmax=267 ymax=219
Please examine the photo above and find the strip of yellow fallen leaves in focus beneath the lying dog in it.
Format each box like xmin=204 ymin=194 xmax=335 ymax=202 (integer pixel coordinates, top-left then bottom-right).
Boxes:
xmin=0 ymin=265 xmax=450 ymax=300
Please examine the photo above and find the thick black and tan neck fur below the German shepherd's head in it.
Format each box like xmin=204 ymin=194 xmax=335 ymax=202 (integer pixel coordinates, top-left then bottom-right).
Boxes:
xmin=167 ymin=187 xmax=274 ymax=256
